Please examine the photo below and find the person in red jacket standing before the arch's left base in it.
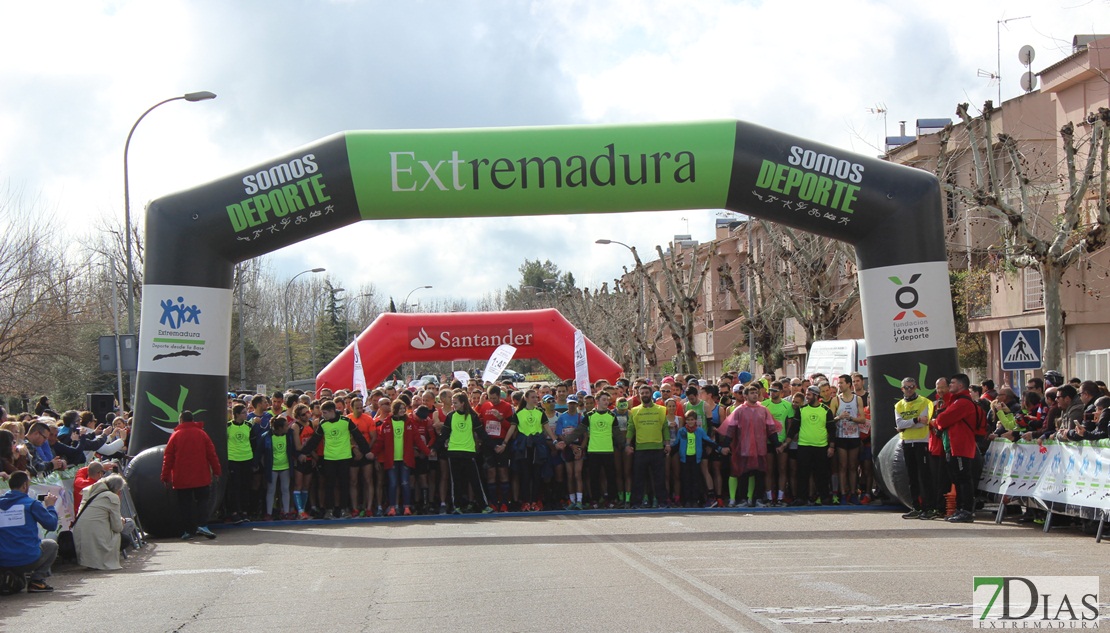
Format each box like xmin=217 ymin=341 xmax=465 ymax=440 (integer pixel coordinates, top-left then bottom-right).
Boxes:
xmin=162 ymin=411 xmax=221 ymax=540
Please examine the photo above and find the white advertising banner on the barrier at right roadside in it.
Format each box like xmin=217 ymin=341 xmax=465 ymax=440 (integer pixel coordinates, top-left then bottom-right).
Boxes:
xmin=979 ymin=440 xmax=1110 ymax=510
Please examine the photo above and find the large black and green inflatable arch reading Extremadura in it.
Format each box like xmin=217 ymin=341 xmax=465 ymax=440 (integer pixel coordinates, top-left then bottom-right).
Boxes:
xmin=129 ymin=121 xmax=957 ymax=534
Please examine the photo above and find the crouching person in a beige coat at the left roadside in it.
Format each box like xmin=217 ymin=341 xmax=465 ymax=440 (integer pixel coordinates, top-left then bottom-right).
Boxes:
xmin=73 ymin=470 xmax=124 ymax=570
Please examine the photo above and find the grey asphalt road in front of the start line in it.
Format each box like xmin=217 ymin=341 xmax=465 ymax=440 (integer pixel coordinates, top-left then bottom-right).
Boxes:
xmin=0 ymin=508 xmax=1110 ymax=633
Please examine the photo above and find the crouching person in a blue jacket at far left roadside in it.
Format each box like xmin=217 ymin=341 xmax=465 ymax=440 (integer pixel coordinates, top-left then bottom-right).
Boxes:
xmin=0 ymin=471 xmax=58 ymax=593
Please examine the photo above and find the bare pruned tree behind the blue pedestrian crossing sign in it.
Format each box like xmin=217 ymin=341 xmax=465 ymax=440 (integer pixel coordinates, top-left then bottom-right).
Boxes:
xmin=937 ymin=101 xmax=1110 ymax=369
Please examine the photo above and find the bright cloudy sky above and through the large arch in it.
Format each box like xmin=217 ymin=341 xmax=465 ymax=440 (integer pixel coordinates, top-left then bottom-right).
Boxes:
xmin=0 ymin=0 xmax=1110 ymax=302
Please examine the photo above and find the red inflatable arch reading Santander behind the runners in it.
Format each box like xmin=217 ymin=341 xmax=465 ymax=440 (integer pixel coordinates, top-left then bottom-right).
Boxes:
xmin=316 ymin=309 xmax=620 ymax=393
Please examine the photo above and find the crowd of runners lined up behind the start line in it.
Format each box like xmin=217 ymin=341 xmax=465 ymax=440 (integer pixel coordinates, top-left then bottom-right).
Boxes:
xmin=216 ymin=372 xmax=888 ymax=522
